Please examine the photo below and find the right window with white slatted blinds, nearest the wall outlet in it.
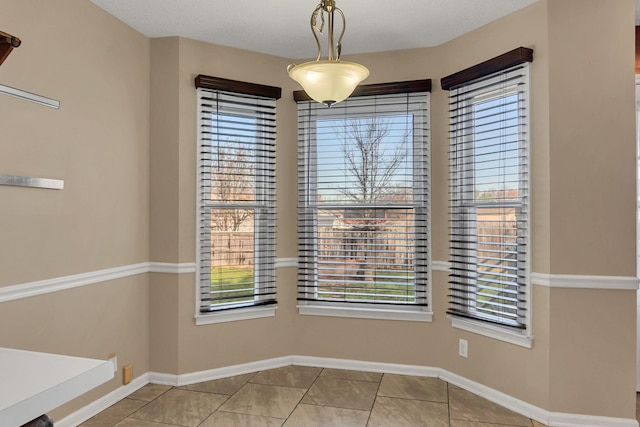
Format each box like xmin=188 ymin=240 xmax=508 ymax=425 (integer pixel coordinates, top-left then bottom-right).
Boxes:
xmin=443 ymin=48 xmax=530 ymax=342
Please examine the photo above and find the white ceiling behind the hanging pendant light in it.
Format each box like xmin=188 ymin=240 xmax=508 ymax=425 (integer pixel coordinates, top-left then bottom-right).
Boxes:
xmin=91 ymin=0 xmax=537 ymax=59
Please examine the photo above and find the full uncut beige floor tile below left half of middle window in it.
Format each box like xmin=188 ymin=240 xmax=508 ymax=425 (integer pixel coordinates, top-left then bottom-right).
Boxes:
xmin=302 ymin=378 xmax=378 ymax=411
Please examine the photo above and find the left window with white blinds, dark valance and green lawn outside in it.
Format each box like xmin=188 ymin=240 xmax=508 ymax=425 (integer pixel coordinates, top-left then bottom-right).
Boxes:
xmin=196 ymin=76 xmax=280 ymax=323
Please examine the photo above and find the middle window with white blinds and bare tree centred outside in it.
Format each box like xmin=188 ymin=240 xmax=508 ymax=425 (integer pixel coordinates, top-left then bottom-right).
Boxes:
xmin=298 ymin=80 xmax=430 ymax=320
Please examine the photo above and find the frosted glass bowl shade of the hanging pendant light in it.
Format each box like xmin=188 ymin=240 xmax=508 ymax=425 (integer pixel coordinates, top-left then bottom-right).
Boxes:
xmin=289 ymin=60 xmax=369 ymax=106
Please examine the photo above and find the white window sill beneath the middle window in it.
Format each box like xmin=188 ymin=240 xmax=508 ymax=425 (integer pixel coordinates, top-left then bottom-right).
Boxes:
xmin=298 ymin=304 xmax=433 ymax=322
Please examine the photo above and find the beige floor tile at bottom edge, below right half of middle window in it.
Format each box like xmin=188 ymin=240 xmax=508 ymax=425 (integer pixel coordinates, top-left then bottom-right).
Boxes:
xmin=367 ymin=396 xmax=449 ymax=427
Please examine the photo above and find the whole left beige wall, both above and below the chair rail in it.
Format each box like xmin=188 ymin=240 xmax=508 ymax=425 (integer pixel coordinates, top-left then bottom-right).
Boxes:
xmin=0 ymin=0 xmax=150 ymax=419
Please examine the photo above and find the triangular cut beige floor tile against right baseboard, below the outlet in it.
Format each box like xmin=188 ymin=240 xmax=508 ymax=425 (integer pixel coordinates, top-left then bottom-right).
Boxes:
xmin=449 ymin=389 xmax=532 ymax=427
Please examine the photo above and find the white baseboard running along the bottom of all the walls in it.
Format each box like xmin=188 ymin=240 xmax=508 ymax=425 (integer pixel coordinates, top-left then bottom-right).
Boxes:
xmin=56 ymin=355 xmax=639 ymax=427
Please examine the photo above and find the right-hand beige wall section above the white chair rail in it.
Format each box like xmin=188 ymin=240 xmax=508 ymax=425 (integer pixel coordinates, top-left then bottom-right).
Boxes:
xmin=549 ymin=0 xmax=635 ymax=276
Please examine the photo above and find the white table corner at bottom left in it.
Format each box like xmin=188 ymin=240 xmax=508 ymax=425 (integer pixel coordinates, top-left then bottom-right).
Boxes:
xmin=0 ymin=347 xmax=113 ymax=426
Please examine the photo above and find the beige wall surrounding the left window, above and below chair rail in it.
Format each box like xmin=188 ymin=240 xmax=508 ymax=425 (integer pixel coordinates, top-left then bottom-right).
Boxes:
xmin=151 ymin=37 xmax=297 ymax=374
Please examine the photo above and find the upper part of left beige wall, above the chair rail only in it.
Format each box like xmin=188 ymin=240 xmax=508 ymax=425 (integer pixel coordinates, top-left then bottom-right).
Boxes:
xmin=0 ymin=0 xmax=149 ymax=285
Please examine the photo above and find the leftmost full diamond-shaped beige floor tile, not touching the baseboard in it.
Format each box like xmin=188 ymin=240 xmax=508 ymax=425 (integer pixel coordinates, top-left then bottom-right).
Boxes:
xmin=130 ymin=389 xmax=229 ymax=427
